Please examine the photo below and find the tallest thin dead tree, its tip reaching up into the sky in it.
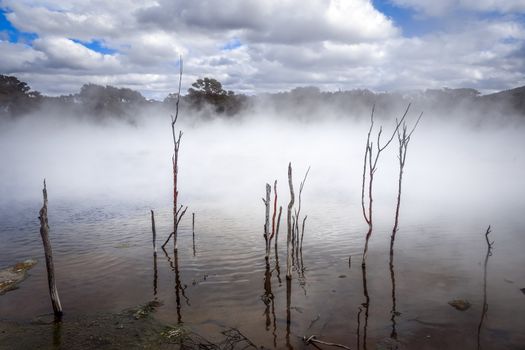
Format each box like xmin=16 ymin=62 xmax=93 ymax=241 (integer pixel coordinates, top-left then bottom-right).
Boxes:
xmin=162 ymin=57 xmax=188 ymax=251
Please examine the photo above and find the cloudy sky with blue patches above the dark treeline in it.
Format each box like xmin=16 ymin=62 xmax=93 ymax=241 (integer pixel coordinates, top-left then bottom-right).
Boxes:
xmin=0 ymin=0 xmax=525 ymax=99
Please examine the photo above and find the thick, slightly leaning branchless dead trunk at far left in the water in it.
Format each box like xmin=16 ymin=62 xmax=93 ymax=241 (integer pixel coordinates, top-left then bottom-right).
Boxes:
xmin=39 ymin=179 xmax=63 ymax=321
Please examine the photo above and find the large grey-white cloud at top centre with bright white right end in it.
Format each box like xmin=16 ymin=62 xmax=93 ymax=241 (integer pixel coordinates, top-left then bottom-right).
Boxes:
xmin=138 ymin=0 xmax=397 ymax=44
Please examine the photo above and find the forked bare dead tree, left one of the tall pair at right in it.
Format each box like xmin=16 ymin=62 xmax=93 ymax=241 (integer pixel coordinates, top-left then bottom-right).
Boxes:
xmin=361 ymin=104 xmax=410 ymax=266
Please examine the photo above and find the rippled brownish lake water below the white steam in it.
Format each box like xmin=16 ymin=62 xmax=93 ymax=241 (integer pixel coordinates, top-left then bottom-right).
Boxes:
xmin=0 ymin=198 xmax=525 ymax=349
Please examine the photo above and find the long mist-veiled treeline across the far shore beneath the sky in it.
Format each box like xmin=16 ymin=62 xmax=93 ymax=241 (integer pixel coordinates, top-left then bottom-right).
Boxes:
xmin=0 ymin=75 xmax=525 ymax=120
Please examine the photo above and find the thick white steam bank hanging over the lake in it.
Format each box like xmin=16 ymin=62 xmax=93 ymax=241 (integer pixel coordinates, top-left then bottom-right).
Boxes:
xmin=0 ymin=107 xmax=525 ymax=227
